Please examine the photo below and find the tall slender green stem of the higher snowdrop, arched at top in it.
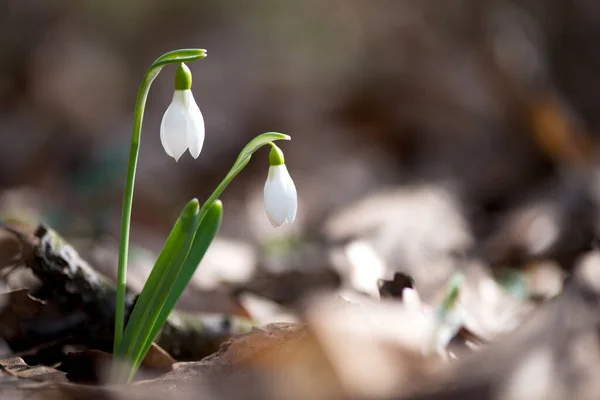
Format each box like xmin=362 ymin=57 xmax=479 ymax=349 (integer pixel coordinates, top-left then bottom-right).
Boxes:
xmin=113 ymin=49 xmax=206 ymax=353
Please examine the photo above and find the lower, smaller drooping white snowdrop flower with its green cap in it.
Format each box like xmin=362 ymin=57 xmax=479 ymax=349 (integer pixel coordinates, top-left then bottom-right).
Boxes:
xmin=264 ymin=143 xmax=298 ymax=228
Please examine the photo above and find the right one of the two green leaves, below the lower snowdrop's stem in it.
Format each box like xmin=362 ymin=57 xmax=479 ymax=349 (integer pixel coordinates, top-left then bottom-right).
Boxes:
xmin=129 ymin=200 xmax=223 ymax=380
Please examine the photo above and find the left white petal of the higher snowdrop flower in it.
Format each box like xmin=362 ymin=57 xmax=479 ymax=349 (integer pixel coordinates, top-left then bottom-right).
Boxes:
xmin=160 ymin=90 xmax=188 ymax=161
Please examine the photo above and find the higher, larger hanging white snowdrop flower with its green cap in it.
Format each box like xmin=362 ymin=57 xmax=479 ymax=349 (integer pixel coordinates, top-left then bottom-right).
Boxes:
xmin=160 ymin=63 xmax=204 ymax=161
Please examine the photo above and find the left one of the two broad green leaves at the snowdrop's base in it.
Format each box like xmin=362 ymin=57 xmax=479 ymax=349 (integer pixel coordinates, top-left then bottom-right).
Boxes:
xmin=117 ymin=199 xmax=200 ymax=368
